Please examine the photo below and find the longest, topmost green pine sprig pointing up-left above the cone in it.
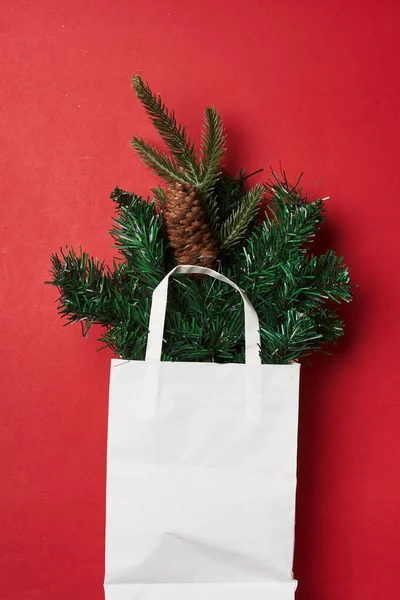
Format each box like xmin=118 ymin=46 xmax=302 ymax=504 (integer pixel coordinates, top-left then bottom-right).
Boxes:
xmin=132 ymin=75 xmax=199 ymax=186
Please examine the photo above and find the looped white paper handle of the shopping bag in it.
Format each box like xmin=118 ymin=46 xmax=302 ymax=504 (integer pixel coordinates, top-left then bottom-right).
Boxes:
xmin=145 ymin=265 xmax=261 ymax=365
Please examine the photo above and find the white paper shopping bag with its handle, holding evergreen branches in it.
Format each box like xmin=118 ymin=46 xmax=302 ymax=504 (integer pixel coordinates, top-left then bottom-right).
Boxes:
xmin=104 ymin=266 xmax=300 ymax=600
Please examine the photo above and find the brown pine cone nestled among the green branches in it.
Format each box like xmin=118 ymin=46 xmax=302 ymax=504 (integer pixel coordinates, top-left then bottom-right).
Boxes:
xmin=163 ymin=183 xmax=218 ymax=269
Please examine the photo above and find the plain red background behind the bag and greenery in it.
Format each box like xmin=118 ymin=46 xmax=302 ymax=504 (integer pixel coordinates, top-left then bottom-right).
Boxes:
xmin=0 ymin=0 xmax=400 ymax=600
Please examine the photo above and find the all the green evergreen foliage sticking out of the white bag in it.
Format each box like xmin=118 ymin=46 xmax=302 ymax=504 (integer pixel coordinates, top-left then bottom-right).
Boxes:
xmin=49 ymin=76 xmax=352 ymax=364
